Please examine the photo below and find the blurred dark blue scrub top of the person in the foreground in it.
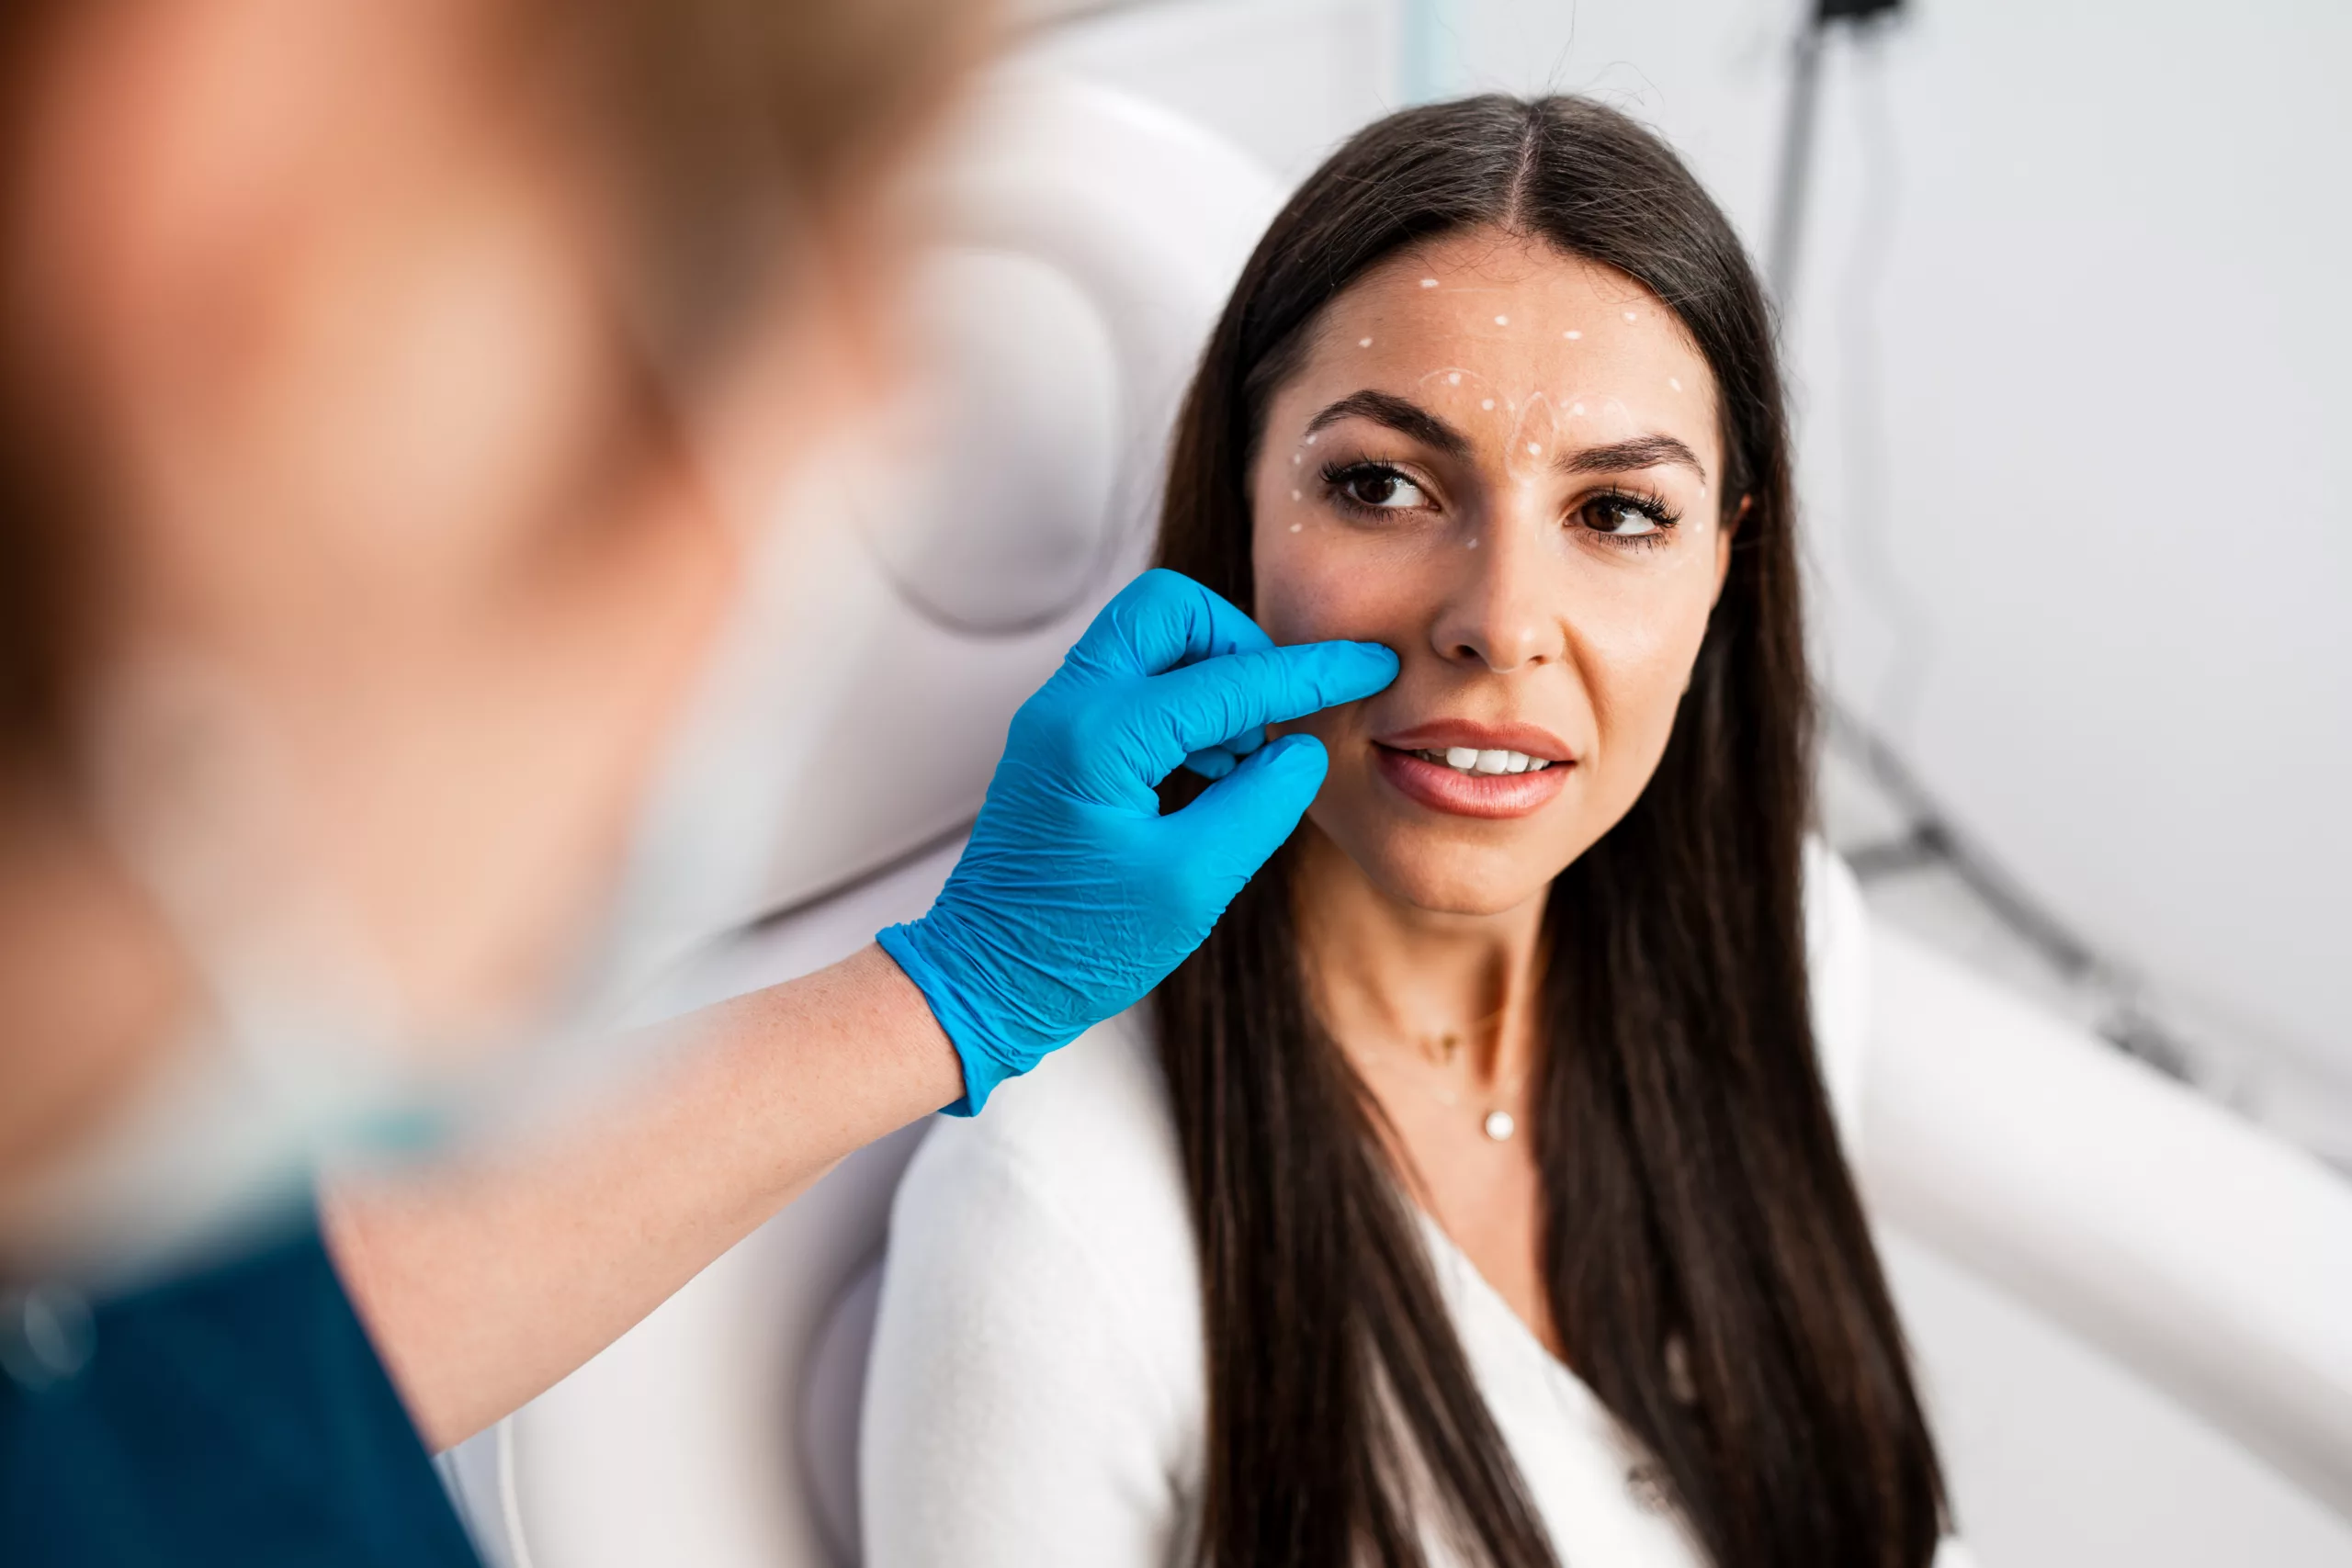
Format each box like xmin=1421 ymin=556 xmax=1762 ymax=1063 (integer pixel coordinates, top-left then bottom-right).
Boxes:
xmin=0 ymin=1218 xmax=478 ymax=1568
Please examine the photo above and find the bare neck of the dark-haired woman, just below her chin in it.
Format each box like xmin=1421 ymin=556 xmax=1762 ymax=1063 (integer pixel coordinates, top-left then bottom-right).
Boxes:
xmin=1291 ymin=825 xmax=1545 ymax=1100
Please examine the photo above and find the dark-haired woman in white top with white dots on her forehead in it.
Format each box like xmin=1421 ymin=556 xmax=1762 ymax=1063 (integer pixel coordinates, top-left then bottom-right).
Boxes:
xmin=865 ymin=96 xmax=1948 ymax=1568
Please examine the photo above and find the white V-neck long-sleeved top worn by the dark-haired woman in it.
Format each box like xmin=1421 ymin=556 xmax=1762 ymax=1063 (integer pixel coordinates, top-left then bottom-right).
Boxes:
xmin=861 ymin=851 xmax=1962 ymax=1568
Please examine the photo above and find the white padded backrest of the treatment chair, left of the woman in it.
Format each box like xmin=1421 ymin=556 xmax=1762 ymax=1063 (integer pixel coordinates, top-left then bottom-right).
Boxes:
xmin=442 ymin=71 xmax=1280 ymax=1568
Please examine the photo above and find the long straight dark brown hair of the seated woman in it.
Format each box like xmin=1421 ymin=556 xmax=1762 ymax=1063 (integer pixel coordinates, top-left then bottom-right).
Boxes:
xmin=1155 ymin=96 xmax=1943 ymax=1568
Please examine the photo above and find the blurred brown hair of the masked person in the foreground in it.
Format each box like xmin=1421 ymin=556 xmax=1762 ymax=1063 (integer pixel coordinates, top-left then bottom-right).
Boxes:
xmin=0 ymin=0 xmax=988 ymax=766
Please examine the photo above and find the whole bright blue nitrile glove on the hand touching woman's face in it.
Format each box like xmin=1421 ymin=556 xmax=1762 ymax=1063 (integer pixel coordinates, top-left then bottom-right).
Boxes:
xmin=875 ymin=571 xmax=1397 ymax=1114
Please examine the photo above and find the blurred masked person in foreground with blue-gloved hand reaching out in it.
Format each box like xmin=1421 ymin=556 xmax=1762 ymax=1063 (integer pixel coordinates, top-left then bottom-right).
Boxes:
xmin=0 ymin=0 xmax=1395 ymax=1563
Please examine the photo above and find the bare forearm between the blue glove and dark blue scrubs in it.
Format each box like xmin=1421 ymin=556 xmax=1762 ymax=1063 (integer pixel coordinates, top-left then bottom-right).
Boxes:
xmin=324 ymin=947 xmax=962 ymax=1448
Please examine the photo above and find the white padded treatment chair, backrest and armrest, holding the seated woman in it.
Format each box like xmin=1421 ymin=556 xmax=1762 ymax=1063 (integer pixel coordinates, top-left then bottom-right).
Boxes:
xmin=445 ymin=75 xmax=2352 ymax=1568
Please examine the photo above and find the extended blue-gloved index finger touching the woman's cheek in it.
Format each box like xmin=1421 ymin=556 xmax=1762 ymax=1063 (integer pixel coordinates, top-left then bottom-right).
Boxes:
xmin=1101 ymin=642 xmax=1397 ymax=783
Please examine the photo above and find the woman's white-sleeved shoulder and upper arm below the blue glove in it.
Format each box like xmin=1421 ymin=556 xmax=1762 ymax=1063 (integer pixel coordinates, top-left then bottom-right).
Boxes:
xmin=858 ymin=1013 xmax=1206 ymax=1565
